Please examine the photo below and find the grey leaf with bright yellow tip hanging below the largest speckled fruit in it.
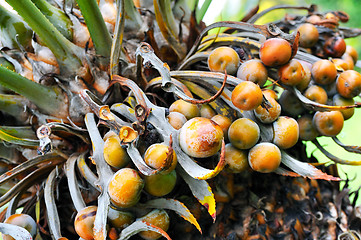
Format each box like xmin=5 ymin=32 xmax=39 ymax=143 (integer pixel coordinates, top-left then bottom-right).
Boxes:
xmin=177 ymin=166 xmax=216 ymax=222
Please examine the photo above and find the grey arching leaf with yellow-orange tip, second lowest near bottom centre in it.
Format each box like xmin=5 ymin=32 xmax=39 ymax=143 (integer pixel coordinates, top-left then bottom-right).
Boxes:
xmin=141 ymin=198 xmax=202 ymax=233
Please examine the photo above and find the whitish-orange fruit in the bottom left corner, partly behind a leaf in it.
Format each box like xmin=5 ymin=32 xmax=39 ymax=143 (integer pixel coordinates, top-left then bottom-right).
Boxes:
xmin=2 ymin=213 xmax=37 ymax=240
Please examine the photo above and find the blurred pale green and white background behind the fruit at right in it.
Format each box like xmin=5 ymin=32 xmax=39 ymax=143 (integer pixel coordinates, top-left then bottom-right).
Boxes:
xmin=195 ymin=0 xmax=361 ymax=205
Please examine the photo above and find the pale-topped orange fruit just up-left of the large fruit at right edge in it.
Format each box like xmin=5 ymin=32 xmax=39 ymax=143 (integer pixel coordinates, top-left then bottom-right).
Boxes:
xmin=311 ymin=59 xmax=337 ymax=85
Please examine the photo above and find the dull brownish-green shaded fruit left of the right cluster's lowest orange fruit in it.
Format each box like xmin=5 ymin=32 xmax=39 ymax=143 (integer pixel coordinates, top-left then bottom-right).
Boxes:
xmin=225 ymin=143 xmax=249 ymax=173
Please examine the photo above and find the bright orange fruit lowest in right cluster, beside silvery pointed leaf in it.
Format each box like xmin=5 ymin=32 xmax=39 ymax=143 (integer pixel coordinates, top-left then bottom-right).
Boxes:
xmin=248 ymin=142 xmax=281 ymax=173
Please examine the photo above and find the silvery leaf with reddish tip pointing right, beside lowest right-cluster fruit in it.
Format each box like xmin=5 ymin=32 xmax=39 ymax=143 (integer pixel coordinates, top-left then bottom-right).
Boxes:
xmin=281 ymin=151 xmax=341 ymax=181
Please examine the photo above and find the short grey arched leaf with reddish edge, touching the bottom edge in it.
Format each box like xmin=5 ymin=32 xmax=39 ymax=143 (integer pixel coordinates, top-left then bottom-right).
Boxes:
xmin=118 ymin=220 xmax=172 ymax=240
